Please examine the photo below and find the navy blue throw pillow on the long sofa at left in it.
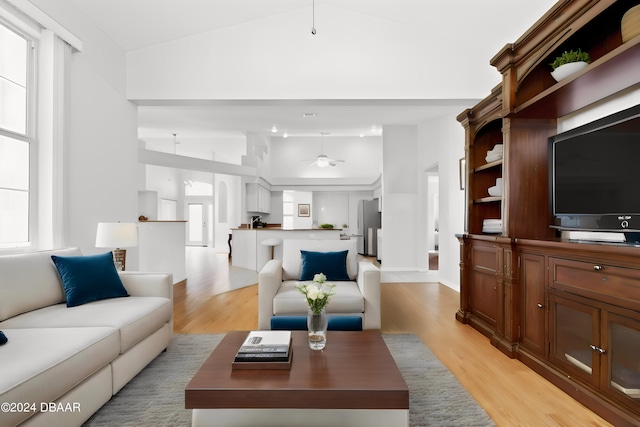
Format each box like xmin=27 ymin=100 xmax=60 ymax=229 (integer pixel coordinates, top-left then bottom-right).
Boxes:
xmin=51 ymin=252 xmax=129 ymax=307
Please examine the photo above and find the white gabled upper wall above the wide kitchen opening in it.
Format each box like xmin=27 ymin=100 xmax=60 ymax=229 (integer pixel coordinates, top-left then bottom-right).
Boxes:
xmin=127 ymin=0 xmax=554 ymax=99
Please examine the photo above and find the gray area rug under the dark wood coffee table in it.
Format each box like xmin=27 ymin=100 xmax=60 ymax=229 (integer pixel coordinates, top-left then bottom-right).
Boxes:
xmin=84 ymin=334 xmax=495 ymax=427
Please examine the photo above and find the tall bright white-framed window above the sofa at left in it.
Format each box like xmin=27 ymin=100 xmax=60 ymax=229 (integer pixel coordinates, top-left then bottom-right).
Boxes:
xmin=0 ymin=21 xmax=35 ymax=248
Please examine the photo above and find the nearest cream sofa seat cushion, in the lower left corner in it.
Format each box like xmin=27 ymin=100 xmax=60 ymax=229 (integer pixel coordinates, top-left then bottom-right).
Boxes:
xmin=0 ymin=328 xmax=118 ymax=425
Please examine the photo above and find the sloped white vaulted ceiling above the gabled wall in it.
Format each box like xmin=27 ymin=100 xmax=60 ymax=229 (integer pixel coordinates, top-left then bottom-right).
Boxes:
xmin=67 ymin=0 xmax=555 ymax=51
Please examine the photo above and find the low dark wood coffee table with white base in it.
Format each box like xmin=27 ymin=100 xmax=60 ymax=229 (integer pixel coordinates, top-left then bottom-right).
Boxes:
xmin=185 ymin=331 xmax=409 ymax=426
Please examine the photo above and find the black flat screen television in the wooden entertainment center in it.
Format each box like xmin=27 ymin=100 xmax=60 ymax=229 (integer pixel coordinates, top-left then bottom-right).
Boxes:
xmin=549 ymin=105 xmax=640 ymax=232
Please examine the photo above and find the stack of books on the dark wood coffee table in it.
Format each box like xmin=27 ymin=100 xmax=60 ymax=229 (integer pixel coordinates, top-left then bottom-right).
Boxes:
xmin=233 ymin=331 xmax=293 ymax=369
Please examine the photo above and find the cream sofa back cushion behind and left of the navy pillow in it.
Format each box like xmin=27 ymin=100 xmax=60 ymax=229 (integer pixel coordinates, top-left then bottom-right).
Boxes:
xmin=0 ymin=248 xmax=80 ymax=321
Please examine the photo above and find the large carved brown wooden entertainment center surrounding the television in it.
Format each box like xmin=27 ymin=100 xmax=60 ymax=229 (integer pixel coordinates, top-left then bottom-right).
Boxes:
xmin=456 ymin=0 xmax=640 ymax=426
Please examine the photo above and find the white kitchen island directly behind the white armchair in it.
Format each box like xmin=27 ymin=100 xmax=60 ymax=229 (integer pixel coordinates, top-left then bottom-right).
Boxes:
xmin=231 ymin=227 xmax=342 ymax=271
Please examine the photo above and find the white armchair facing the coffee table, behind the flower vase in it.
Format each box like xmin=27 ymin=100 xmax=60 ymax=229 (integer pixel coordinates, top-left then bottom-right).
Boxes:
xmin=258 ymin=239 xmax=380 ymax=329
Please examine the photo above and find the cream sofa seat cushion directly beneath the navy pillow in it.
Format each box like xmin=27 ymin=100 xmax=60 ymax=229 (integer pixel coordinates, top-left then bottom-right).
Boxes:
xmin=2 ymin=296 xmax=173 ymax=353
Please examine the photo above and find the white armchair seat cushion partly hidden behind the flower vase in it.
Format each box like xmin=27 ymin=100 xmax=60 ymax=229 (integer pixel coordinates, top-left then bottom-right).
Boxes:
xmin=273 ymin=280 xmax=364 ymax=316
